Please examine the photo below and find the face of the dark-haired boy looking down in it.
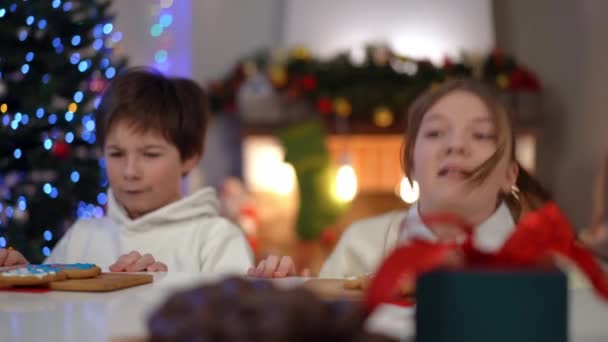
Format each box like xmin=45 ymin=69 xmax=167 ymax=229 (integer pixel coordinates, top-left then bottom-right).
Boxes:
xmin=103 ymin=121 xmax=199 ymax=219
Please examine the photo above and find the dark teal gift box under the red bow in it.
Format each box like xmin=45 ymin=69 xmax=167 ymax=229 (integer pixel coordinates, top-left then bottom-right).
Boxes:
xmin=416 ymin=268 xmax=568 ymax=342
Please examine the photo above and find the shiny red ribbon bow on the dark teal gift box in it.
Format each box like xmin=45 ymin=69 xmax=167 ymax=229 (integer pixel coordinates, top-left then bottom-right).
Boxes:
xmin=364 ymin=202 xmax=608 ymax=312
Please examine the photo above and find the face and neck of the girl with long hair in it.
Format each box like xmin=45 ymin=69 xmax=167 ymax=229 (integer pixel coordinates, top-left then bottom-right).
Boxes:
xmin=412 ymin=90 xmax=518 ymax=224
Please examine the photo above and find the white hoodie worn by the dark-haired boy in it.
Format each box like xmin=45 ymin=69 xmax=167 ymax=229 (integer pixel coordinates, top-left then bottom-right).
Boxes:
xmin=45 ymin=188 xmax=253 ymax=274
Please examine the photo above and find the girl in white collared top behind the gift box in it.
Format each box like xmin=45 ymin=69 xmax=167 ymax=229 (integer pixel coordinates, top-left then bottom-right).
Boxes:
xmin=248 ymin=79 xmax=549 ymax=278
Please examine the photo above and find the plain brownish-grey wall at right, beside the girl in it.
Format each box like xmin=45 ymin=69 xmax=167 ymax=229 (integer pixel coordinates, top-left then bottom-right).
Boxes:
xmin=494 ymin=0 xmax=608 ymax=228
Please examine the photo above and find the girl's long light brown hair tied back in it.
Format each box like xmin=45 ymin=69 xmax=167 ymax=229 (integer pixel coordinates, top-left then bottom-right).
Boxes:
xmin=401 ymin=78 xmax=550 ymax=219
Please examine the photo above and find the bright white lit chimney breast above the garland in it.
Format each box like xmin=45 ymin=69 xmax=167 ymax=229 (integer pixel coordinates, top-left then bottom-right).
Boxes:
xmin=283 ymin=0 xmax=494 ymax=62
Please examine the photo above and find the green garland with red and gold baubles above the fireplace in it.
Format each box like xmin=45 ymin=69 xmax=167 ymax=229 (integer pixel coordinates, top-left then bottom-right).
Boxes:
xmin=209 ymin=46 xmax=540 ymax=127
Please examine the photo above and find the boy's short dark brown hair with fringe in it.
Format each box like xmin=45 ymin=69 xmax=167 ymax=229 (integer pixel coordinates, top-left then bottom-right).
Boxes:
xmin=95 ymin=67 xmax=208 ymax=160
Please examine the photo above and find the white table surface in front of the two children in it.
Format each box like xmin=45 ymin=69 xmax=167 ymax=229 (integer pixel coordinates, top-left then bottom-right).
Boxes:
xmin=0 ymin=272 xmax=608 ymax=342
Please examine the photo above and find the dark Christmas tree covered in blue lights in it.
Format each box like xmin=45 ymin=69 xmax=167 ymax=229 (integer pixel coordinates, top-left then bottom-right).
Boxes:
xmin=0 ymin=0 xmax=125 ymax=262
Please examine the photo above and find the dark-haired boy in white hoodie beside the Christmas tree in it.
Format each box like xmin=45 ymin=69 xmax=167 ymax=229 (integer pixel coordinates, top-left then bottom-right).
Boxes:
xmin=2 ymin=68 xmax=252 ymax=274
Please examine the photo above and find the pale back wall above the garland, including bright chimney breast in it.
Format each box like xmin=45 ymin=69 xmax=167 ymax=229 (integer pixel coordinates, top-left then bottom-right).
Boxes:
xmin=113 ymin=0 xmax=495 ymax=81
